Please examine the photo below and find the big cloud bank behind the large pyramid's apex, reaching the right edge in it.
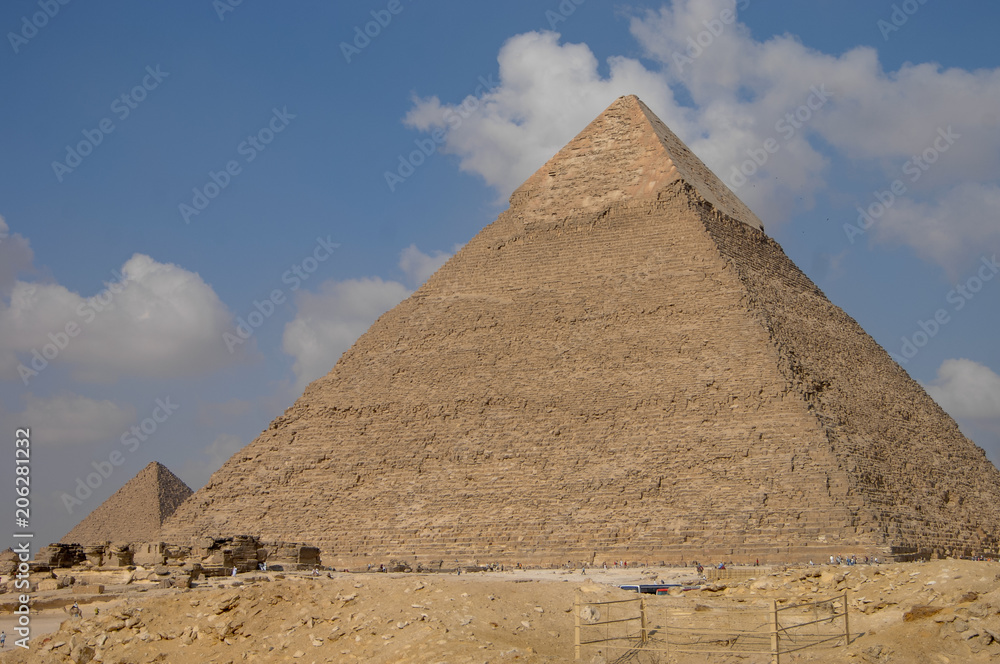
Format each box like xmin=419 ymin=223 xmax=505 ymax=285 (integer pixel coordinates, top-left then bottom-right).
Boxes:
xmin=404 ymin=0 xmax=1000 ymax=270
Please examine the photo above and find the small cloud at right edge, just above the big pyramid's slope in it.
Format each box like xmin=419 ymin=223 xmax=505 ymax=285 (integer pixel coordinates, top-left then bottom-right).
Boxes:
xmin=925 ymin=359 xmax=1000 ymax=419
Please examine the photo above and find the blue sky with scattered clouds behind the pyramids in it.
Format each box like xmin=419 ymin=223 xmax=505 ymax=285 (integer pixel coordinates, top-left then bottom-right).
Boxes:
xmin=0 ymin=0 xmax=1000 ymax=542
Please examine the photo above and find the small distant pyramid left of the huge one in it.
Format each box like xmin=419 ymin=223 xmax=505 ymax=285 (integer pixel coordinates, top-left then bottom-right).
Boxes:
xmin=62 ymin=461 xmax=194 ymax=546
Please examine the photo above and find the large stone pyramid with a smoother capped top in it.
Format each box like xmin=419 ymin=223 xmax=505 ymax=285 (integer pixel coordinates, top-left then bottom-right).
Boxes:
xmin=164 ymin=97 xmax=1000 ymax=564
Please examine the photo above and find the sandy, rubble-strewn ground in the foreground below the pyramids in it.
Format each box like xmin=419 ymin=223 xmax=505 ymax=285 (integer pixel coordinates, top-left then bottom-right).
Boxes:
xmin=0 ymin=560 xmax=1000 ymax=664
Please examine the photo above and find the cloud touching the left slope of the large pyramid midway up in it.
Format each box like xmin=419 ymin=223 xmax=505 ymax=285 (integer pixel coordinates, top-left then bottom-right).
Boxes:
xmin=282 ymin=277 xmax=410 ymax=392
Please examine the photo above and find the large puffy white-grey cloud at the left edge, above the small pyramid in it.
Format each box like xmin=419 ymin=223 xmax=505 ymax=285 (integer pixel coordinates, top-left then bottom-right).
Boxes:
xmin=0 ymin=254 xmax=242 ymax=384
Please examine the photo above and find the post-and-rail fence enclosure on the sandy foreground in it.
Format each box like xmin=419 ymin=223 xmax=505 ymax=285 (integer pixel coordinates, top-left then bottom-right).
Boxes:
xmin=574 ymin=593 xmax=850 ymax=664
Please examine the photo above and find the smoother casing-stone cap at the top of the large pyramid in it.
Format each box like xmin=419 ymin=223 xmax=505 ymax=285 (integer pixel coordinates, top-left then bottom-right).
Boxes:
xmin=511 ymin=95 xmax=764 ymax=230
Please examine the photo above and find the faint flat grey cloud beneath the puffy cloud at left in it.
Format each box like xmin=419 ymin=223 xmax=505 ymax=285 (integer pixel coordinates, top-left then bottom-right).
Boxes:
xmin=17 ymin=393 xmax=135 ymax=445
